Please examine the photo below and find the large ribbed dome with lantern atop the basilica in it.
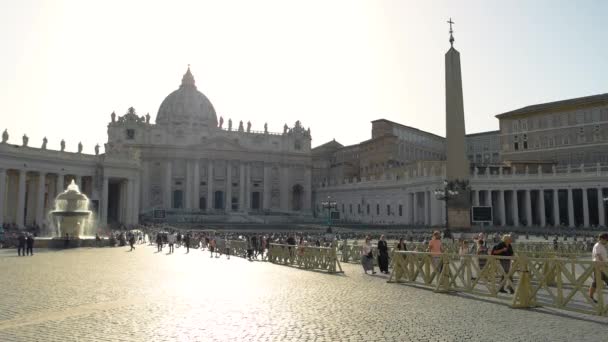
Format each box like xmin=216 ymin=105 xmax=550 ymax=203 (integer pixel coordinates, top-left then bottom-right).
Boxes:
xmin=156 ymin=67 xmax=217 ymax=127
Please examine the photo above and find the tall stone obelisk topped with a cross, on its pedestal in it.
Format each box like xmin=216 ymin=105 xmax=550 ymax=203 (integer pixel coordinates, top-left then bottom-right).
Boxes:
xmin=445 ymin=18 xmax=471 ymax=228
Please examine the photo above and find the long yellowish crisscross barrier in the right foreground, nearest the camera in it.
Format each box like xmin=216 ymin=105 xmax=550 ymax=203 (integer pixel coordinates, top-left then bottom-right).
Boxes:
xmin=388 ymin=251 xmax=608 ymax=316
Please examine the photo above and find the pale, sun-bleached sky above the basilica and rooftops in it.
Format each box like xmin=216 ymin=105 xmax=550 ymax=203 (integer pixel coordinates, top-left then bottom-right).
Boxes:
xmin=0 ymin=0 xmax=608 ymax=153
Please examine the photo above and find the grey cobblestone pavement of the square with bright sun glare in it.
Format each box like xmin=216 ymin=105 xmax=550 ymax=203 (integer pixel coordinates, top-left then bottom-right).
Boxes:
xmin=0 ymin=246 xmax=608 ymax=342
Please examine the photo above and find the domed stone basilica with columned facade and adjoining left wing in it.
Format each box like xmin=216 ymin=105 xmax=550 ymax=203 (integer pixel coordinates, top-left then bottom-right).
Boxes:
xmin=0 ymin=68 xmax=312 ymax=226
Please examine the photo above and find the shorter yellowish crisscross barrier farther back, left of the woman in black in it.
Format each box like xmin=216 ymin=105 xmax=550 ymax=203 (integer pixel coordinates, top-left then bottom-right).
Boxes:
xmin=268 ymin=243 xmax=344 ymax=273
